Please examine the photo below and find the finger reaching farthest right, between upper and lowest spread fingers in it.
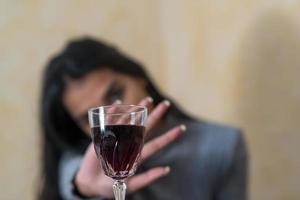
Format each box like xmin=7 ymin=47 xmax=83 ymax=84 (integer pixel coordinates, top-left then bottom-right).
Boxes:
xmin=140 ymin=125 xmax=186 ymax=162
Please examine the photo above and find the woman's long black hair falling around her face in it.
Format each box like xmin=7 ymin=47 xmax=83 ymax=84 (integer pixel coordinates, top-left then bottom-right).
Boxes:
xmin=38 ymin=37 xmax=187 ymax=200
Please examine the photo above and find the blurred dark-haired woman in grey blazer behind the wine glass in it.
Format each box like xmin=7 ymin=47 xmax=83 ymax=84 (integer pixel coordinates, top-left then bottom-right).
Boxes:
xmin=39 ymin=38 xmax=247 ymax=200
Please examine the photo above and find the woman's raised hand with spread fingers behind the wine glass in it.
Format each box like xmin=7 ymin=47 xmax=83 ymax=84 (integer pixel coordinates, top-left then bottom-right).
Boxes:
xmin=75 ymin=97 xmax=185 ymax=198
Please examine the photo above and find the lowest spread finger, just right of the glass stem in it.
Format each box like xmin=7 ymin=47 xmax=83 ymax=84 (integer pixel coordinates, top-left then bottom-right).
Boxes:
xmin=126 ymin=167 xmax=170 ymax=193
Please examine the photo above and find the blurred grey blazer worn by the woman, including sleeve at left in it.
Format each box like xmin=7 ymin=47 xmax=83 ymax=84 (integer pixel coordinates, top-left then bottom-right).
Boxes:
xmin=59 ymin=117 xmax=247 ymax=200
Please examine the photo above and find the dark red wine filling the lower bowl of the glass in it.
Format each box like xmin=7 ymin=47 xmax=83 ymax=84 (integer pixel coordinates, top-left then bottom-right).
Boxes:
xmin=91 ymin=124 xmax=145 ymax=180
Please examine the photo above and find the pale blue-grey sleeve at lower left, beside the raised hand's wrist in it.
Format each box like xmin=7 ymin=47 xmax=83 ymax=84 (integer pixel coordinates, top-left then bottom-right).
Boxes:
xmin=58 ymin=152 xmax=103 ymax=200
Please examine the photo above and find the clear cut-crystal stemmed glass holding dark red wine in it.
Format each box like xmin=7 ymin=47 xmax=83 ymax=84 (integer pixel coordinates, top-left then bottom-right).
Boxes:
xmin=88 ymin=104 xmax=147 ymax=200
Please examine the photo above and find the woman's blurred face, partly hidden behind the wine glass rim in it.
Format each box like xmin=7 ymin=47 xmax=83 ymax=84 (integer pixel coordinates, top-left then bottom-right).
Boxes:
xmin=63 ymin=69 xmax=147 ymax=134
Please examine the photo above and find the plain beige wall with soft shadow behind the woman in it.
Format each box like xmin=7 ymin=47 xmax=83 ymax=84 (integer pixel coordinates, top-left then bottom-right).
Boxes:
xmin=0 ymin=0 xmax=300 ymax=200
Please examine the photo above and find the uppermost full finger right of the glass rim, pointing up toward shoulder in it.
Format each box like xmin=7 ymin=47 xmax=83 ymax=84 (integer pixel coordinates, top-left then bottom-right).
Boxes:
xmin=146 ymin=100 xmax=170 ymax=133
